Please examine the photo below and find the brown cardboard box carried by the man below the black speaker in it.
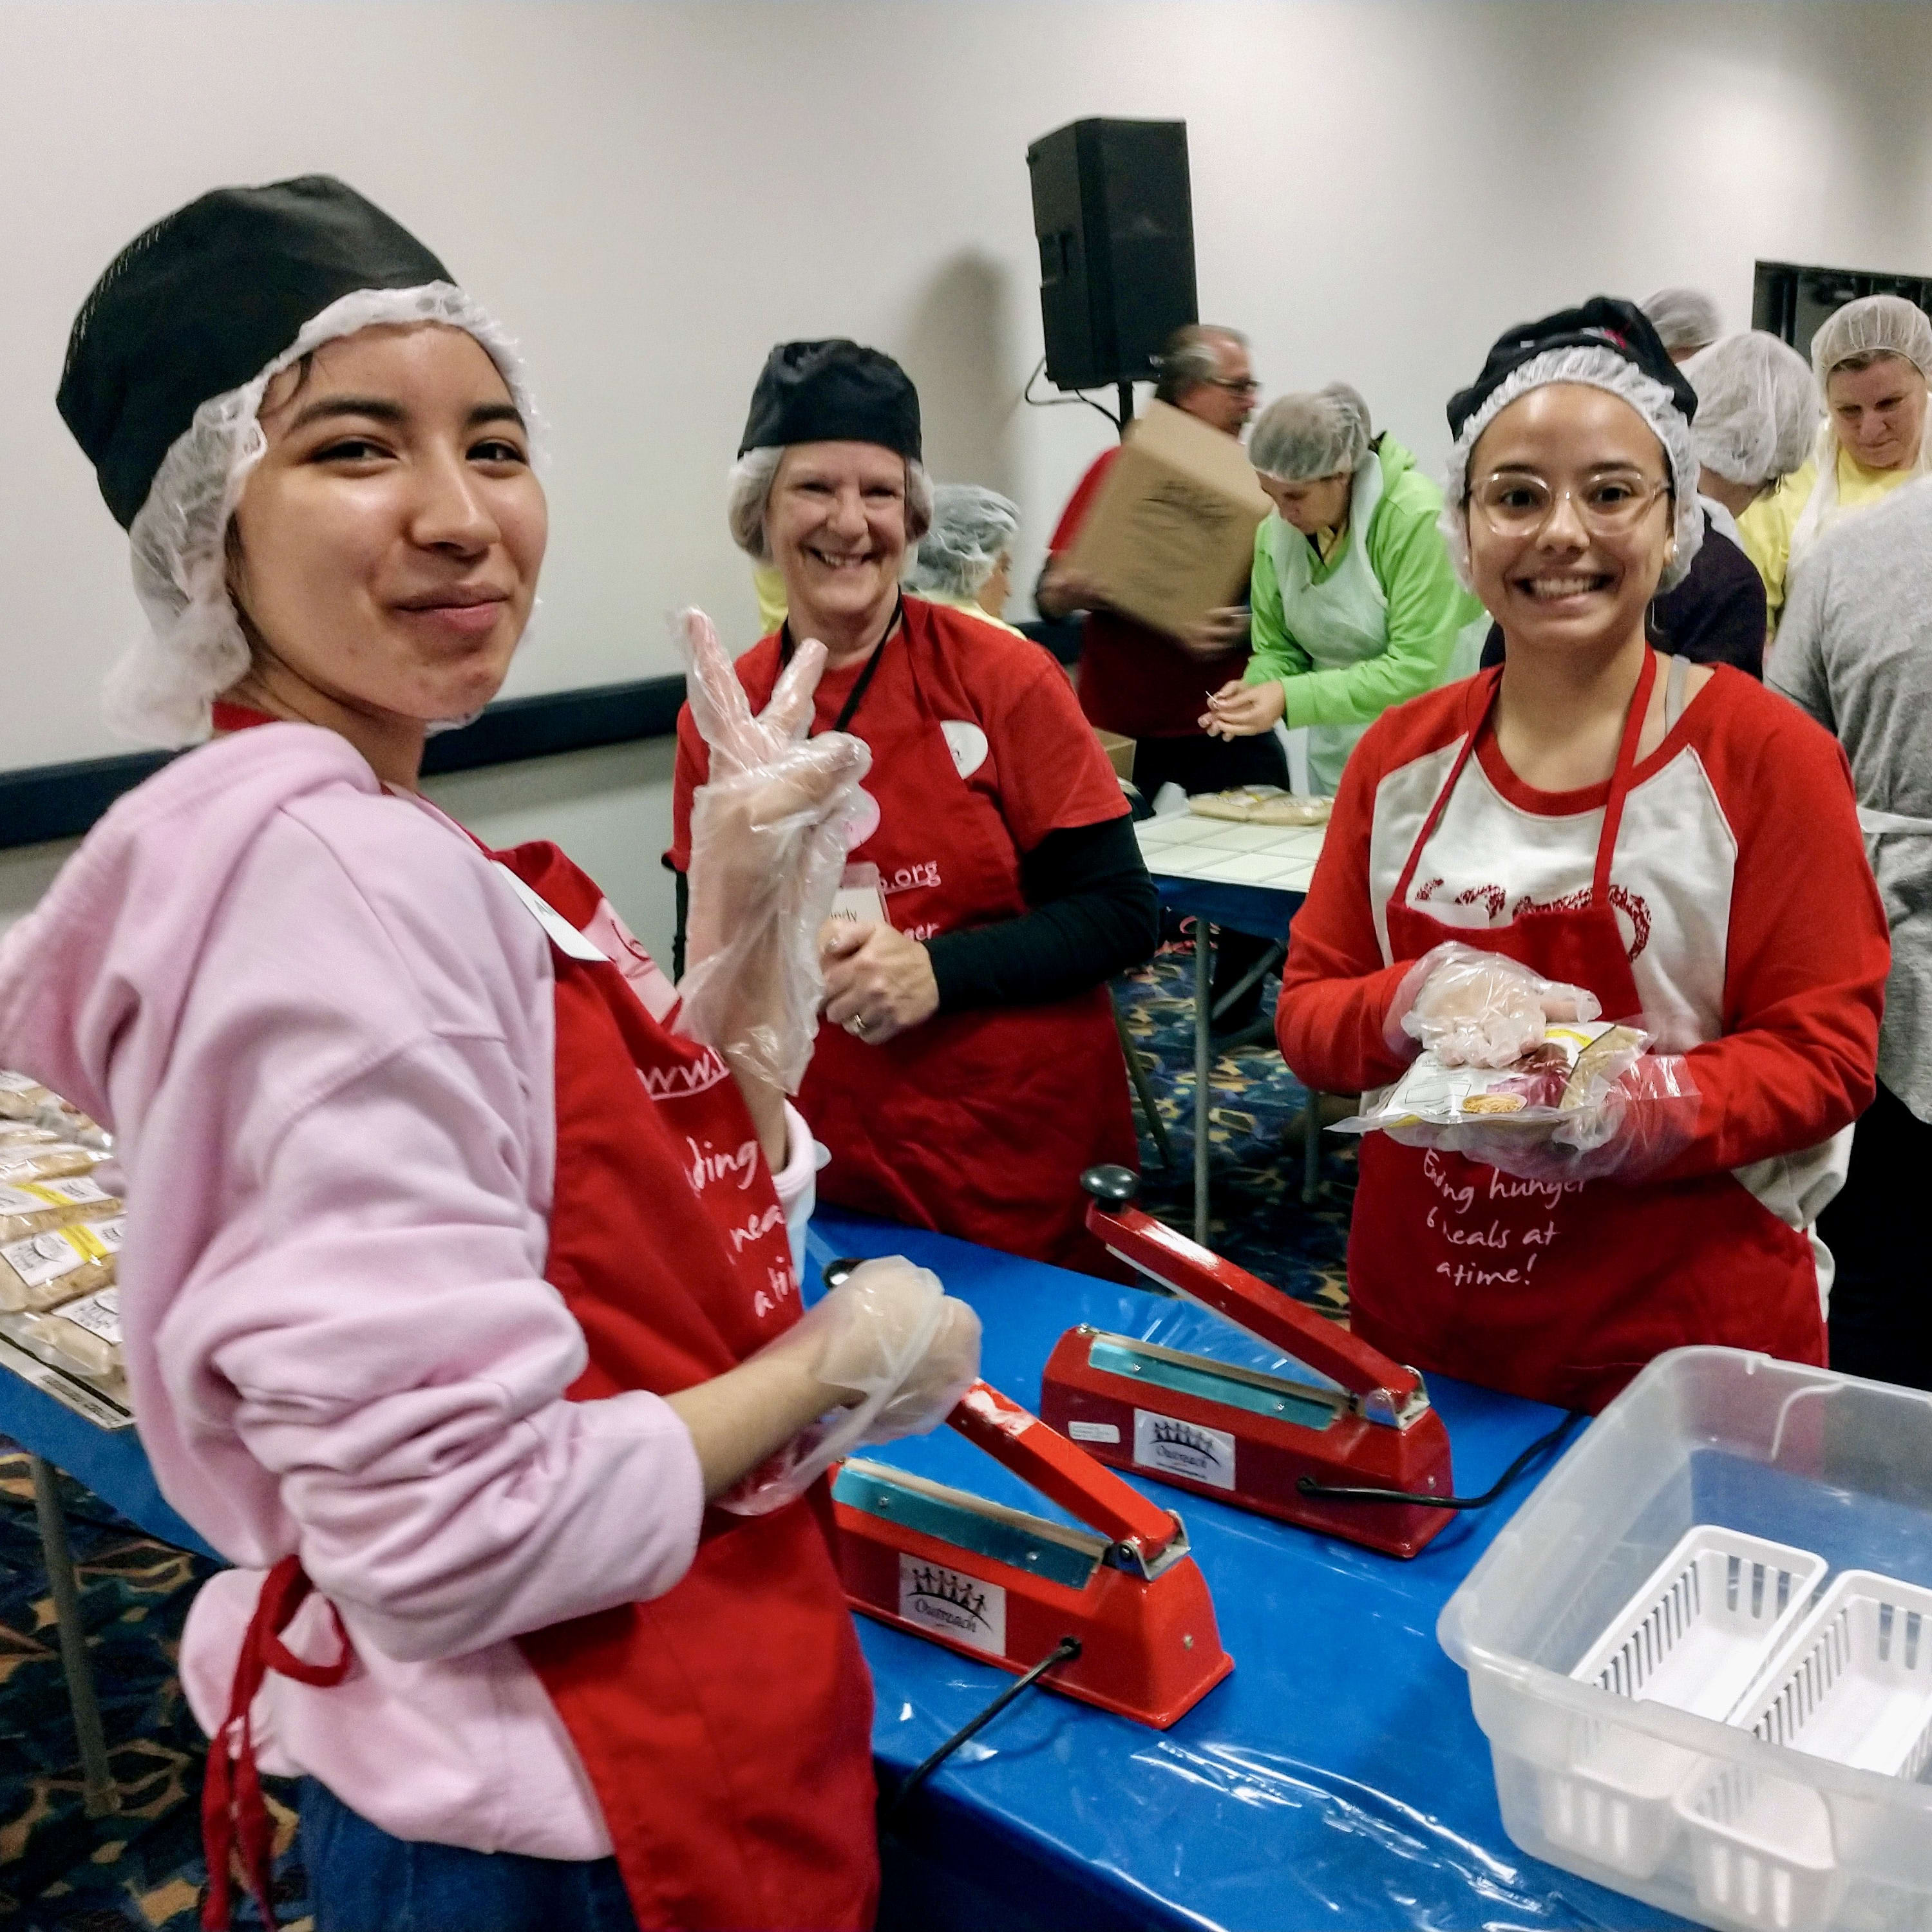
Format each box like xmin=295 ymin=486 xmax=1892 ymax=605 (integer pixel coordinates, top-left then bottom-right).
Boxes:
xmin=1066 ymin=402 xmax=1271 ymax=636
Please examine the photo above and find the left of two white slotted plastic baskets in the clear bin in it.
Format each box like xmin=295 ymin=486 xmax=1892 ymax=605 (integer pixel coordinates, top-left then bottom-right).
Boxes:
xmin=1538 ymin=1522 xmax=1826 ymax=1878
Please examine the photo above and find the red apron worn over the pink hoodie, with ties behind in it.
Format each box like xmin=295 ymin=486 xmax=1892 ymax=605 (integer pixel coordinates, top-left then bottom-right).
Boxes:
xmin=203 ymin=844 xmax=877 ymax=1932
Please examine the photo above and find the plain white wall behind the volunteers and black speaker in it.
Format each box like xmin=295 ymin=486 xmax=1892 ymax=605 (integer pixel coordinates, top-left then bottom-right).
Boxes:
xmin=0 ymin=0 xmax=1932 ymax=898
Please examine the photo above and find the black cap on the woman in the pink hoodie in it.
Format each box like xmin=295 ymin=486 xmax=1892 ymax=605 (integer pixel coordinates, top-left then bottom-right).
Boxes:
xmin=58 ymin=174 xmax=450 ymax=529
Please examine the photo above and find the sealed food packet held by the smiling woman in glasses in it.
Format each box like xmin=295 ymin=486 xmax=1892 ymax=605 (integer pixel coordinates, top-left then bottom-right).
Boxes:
xmin=1337 ymin=1020 xmax=1650 ymax=1134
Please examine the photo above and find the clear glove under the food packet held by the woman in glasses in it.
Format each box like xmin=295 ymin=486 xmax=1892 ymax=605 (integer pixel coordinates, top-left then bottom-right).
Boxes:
xmin=1387 ymin=1053 xmax=1700 ymax=1182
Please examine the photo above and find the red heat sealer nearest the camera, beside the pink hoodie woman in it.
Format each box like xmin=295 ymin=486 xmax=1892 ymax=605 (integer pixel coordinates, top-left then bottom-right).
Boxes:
xmin=825 ymin=1368 xmax=1235 ymax=1731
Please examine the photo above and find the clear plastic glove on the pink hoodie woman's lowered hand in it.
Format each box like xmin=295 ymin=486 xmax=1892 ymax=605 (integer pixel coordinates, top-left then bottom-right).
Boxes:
xmin=719 ymin=1254 xmax=980 ymax=1517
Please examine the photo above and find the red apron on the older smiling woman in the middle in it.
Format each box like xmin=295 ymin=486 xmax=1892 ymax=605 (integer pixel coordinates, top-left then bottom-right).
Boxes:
xmin=796 ymin=601 xmax=1140 ymax=1273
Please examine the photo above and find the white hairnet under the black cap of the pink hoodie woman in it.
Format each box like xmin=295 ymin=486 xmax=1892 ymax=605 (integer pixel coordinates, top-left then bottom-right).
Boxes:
xmin=102 ymin=282 xmax=535 ymax=746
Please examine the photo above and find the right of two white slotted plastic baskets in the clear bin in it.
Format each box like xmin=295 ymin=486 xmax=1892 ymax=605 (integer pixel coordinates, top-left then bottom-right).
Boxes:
xmin=1675 ymin=1571 xmax=1932 ymax=1932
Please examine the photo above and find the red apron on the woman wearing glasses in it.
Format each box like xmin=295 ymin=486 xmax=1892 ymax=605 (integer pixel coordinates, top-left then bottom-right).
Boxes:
xmin=1349 ymin=651 xmax=1826 ymax=1410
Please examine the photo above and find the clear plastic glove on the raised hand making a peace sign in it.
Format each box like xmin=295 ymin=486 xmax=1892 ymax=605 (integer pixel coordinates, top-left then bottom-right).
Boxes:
xmin=672 ymin=611 xmax=871 ymax=1094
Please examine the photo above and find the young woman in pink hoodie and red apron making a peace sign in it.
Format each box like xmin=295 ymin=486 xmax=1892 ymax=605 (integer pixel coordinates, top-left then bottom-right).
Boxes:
xmin=0 ymin=178 xmax=978 ymax=1932
